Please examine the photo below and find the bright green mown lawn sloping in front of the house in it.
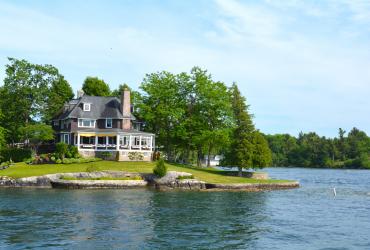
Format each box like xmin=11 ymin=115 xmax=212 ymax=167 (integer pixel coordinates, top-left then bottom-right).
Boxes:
xmin=0 ymin=161 xmax=292 ymax=184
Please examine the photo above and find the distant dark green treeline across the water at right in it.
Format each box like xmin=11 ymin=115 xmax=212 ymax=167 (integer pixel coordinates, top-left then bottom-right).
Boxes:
xmin=265 ymin=128 xmax=370 ymax=168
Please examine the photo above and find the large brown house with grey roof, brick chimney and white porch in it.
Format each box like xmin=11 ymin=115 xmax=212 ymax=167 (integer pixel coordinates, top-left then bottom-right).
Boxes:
xmin=52 ymin=90 xmax=155 ymax=161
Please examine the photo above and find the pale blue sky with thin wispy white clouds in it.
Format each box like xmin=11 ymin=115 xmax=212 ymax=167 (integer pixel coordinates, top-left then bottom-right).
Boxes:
xmin=0 ymin=0 xmax=370 ymax=137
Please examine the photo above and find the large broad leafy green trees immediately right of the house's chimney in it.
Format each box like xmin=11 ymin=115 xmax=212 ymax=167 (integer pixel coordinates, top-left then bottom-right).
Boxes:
xmin=136 ymin=67 xmax=232 ymax=164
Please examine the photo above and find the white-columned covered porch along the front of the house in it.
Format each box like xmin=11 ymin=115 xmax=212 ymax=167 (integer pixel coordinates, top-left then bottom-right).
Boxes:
xmin=74 ymin=132 xmax=155 ymax=152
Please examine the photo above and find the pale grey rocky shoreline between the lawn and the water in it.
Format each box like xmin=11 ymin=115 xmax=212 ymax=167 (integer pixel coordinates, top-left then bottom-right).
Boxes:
xmin=0 ymin=171 xmax=299 ymax=192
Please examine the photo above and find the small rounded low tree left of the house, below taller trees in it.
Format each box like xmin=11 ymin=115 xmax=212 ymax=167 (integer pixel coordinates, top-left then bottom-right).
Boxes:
xmin=19 ymin=123 xmax=54 ymax=152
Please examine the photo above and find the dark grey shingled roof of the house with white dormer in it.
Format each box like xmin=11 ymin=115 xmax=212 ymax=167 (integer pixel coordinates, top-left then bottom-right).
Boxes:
xmin=53 ymin=95 xmax=135 ymax=120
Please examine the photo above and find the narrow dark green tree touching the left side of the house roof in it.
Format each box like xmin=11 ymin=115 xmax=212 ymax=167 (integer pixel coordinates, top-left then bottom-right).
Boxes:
xmin=44 ymin=77 xmax=74 ymax=122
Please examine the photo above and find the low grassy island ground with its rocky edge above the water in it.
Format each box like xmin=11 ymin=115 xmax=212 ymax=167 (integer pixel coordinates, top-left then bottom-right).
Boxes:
xmin=0 ymin=161 xmax=299 ymax=191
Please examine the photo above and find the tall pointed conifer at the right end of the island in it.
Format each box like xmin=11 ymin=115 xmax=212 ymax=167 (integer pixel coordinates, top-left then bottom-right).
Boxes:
xmin=223 ymin=83 xmax=271 ymax=176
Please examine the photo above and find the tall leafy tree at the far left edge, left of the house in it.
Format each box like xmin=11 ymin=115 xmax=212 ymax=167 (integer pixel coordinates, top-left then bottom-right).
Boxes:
xmin=0 ymin=58 xmax=69 ymax=142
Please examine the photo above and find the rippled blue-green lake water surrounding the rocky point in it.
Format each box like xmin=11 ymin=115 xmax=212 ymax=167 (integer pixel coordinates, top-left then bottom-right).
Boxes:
xmin=0 ymin=168 xmax=370 ymax=249
